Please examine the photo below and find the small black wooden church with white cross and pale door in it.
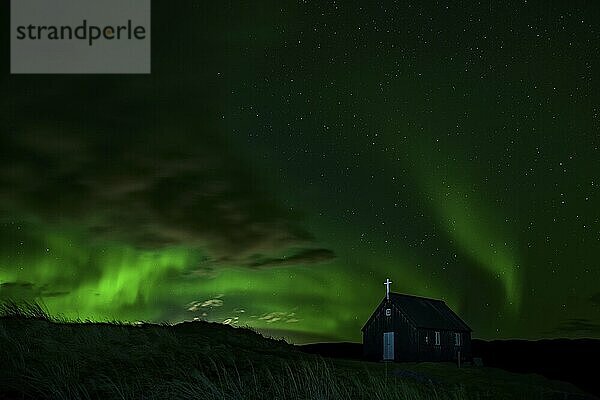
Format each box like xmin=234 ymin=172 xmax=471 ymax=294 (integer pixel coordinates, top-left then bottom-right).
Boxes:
xmin=362 ymin=279 xmax=471 ymax=361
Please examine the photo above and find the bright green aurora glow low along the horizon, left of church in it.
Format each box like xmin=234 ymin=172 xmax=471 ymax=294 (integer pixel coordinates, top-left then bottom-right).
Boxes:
xmin=0 ymin=219 xmax=458 ymax=342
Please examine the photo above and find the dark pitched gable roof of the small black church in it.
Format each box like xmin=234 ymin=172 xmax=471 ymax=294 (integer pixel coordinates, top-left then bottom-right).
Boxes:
xmin=365 ymin=293 xmax=471 ymax=331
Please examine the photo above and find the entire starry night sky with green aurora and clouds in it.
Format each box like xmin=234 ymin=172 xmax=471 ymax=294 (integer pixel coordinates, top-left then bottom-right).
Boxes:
xmin=0 ymin=0 xmax=600 ymax=342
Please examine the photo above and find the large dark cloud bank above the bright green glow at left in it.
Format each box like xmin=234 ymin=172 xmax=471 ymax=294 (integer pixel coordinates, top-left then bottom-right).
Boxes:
xmin=0 ymin=99 xmax=331 ymax=266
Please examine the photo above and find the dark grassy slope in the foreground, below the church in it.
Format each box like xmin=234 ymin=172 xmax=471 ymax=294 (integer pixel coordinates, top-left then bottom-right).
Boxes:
xmin=0 ymin=303 xmax=585 ymax=400
